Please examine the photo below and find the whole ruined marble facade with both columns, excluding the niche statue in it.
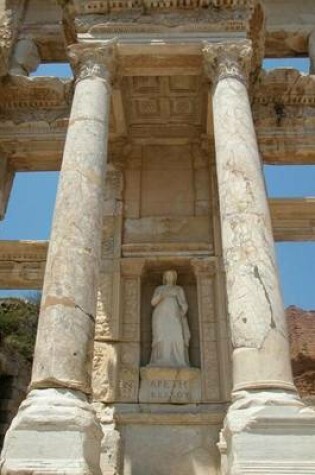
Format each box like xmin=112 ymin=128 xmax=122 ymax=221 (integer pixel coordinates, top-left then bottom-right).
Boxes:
xmin=0 ymin=0 xmax=315 ymax=475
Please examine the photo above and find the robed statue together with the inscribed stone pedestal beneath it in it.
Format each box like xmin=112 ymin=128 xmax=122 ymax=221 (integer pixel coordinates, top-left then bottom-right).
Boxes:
xmin=139 ymin=270 xmax=201 ymax=404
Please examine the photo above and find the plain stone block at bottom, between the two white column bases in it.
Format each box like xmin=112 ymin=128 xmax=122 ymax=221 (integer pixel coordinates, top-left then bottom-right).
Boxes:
xmin=121 ymin=424 xmax=220 ymax=475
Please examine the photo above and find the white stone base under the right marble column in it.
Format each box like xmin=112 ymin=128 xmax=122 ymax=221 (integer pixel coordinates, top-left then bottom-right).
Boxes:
xmin=218 ymin=390 xmax=315 ymax=475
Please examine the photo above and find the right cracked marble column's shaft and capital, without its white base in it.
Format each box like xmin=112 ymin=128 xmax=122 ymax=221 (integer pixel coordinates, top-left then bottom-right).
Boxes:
xmin=204 ymin=40 xmax=294 ymax=391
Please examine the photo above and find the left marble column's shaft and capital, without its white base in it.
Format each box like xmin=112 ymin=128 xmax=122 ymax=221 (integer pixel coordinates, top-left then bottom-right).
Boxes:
xmin=31 ymin=45 xmax=116 ymax=393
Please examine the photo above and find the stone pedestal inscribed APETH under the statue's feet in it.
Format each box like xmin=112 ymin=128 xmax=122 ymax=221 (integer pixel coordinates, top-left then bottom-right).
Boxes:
xmin=139 ymin=366 xmax=201 ymax=404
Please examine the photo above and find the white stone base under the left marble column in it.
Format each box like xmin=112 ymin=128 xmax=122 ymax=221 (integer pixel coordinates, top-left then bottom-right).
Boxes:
xmin=0 ymin=389 xmax=102 ymax=475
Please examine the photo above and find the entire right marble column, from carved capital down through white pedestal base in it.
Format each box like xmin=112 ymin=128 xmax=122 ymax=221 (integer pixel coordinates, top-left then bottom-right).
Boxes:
xmin=204 ymin=40 xmax=315 ymax=475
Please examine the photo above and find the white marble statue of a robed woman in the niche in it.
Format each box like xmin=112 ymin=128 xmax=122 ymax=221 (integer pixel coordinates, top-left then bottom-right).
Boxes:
xmin=149 ymin=270 xmax=190 ymax=367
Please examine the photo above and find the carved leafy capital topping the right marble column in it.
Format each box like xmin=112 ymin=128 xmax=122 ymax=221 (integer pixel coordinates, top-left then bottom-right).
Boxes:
xmin=202 ymin=40 xmax=253 ymax=84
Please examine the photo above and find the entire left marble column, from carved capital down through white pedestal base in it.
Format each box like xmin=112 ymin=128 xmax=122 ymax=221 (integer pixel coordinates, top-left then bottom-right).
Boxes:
xmin=1 ymin=43 xmax=115 ymax=474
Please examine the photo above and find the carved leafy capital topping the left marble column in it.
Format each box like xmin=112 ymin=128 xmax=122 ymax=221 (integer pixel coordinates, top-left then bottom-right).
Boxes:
xmin=68 ymin=39 xmax=117 ymax=84
